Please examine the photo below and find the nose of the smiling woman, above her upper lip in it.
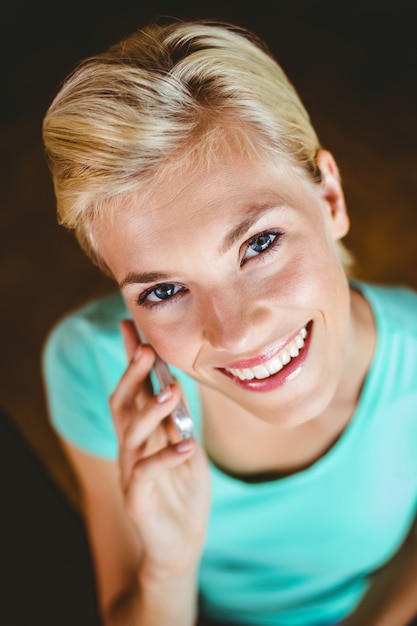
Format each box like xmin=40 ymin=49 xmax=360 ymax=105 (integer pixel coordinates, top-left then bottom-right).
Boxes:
xmin=200 ymin=290 xmax=267 ymax=354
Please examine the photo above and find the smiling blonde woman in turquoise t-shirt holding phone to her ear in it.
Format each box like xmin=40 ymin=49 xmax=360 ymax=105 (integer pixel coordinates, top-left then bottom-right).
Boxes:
xmin=43 ymin=21 xmax=417 ymax=626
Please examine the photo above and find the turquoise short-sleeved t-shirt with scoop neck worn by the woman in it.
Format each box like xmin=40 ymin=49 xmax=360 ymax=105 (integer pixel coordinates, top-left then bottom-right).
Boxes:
xmin=43 ymin=282 xmax=417 ymax=626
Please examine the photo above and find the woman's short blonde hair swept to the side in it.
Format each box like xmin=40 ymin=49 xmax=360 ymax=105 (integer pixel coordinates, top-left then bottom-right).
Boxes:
xmin=43 ymin=21 xmax=352 ymax=271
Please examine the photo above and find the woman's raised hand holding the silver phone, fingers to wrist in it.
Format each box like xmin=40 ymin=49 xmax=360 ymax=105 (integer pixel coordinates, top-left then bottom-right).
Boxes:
xmin=110 ymin=320 xmax=210 ymax=577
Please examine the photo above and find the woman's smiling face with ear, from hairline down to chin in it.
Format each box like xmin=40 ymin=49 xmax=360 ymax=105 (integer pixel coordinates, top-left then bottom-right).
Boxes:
xmin=95 ymin=152 xmax=349 ymax=425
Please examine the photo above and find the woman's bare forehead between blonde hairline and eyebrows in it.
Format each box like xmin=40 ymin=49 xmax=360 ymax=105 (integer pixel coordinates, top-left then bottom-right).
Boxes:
xmin=94 ymin=147 xmax=310 ymax=277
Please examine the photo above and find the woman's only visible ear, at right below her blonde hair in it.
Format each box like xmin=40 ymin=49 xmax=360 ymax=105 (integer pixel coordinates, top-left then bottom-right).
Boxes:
xmin=317 ymin=150 xmax=349 ymax=239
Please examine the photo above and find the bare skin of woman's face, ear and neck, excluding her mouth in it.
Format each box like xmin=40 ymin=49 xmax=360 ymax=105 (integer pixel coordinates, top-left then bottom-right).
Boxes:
xmin=95 ymin=151 xmax=374 ymax=471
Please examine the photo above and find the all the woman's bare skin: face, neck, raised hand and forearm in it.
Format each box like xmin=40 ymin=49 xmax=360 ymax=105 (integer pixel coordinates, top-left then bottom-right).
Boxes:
xmin=64 ymin=145 xmax=414 ymax=626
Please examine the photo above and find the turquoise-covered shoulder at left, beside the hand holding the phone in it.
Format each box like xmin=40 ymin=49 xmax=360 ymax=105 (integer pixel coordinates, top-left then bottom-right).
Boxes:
xmin=42 ymin=293 xmax=129 ymax=458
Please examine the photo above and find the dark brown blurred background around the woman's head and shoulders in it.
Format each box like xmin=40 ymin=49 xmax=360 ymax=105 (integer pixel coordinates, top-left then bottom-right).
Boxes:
xmin=0 ymin=0 xmax=417 ymax=626
